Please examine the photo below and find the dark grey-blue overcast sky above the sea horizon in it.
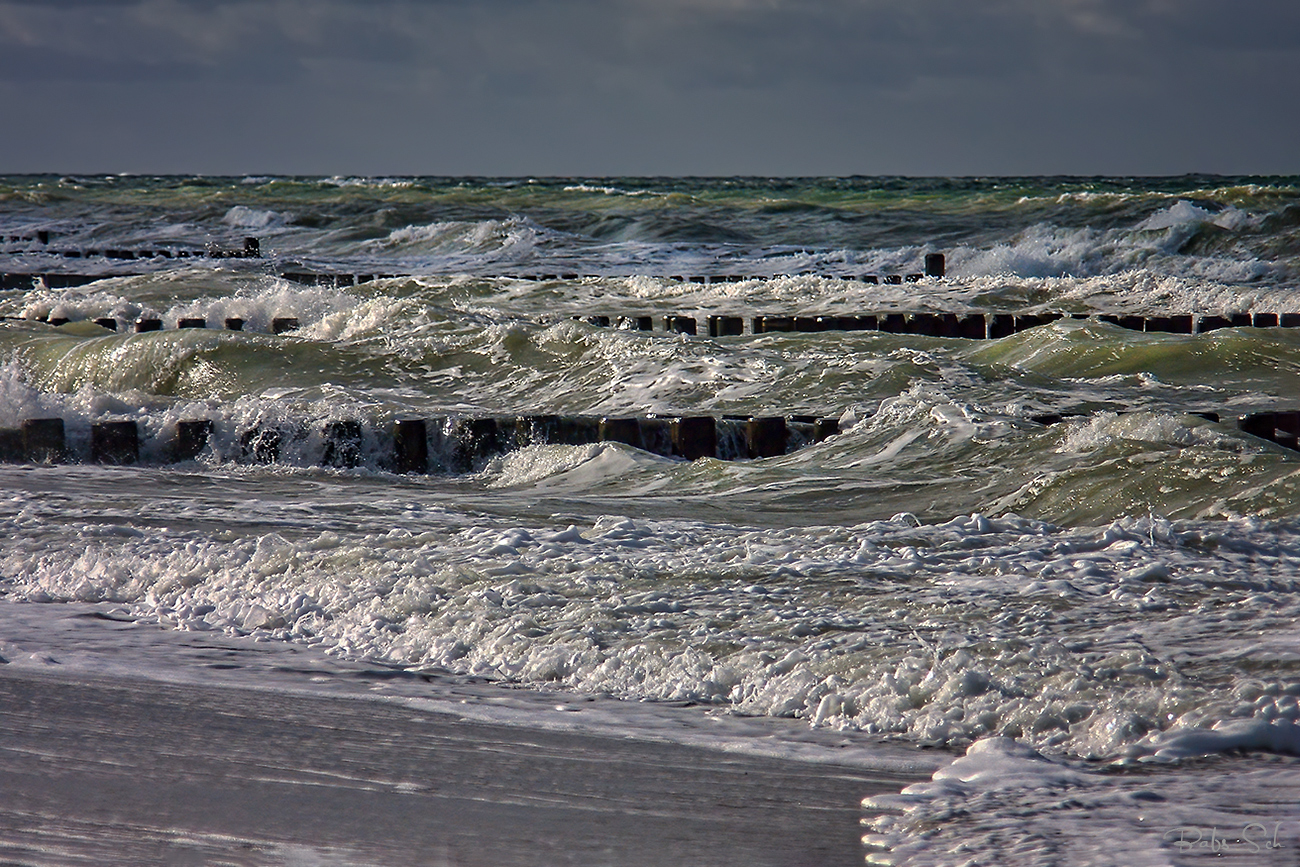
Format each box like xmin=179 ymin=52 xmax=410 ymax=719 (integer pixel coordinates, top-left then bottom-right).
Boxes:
xmin=0 ymin=0 xmax=1300 ymax=175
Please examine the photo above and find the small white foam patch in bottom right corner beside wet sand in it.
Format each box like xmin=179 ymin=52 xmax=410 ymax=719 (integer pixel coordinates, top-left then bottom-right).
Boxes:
xmin=862 ymin=738 xmax=1300 ymax=867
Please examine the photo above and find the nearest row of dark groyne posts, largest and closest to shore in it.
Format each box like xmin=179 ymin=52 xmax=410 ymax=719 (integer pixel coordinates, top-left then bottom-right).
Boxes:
xmin=0 ymin=411 xmax=1300 ymax=473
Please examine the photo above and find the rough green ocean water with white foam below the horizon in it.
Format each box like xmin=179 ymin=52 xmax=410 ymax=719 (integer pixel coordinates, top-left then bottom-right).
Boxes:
xmin=0 ymin=177 xmax=1300 ymax=864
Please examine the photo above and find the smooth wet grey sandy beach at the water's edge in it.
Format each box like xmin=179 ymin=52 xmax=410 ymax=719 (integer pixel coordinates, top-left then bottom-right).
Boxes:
xmin=0 ymin=606 xmax=935 ymax=867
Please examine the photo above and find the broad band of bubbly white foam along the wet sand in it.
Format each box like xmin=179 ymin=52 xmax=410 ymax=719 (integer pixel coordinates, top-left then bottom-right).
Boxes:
xmin=0 ymin=493 xmax=1296 ymax=757
